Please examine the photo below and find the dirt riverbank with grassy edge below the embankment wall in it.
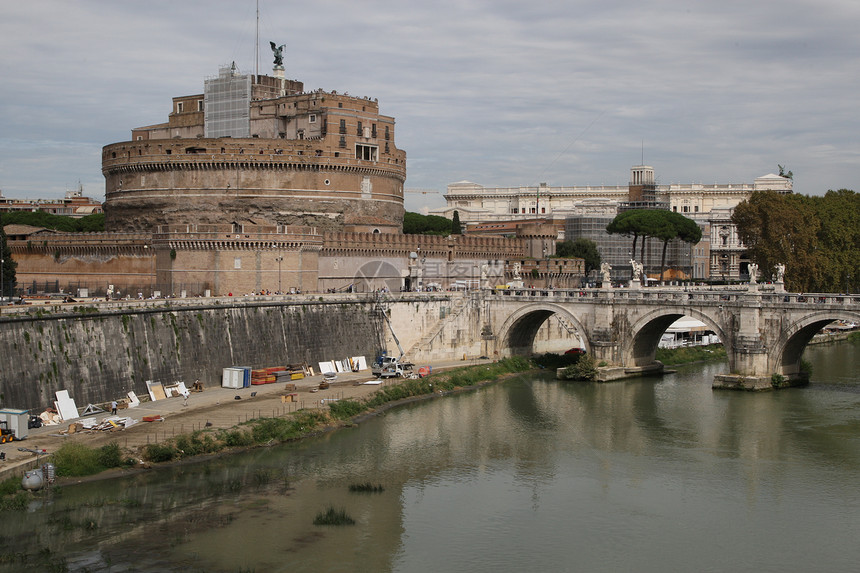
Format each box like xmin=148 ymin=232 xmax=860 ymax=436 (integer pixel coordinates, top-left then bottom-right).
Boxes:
xmin=0 ymin=358 xmax=532 ymax=494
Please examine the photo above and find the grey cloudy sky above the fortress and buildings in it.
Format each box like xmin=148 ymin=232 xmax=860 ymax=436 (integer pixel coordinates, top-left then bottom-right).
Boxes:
xmin=0 ymin=0 xmax=860 ymax=211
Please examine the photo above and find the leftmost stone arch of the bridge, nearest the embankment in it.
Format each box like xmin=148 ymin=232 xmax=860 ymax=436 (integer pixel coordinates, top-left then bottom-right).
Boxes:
xmin=497 ymin=303 xmax=591 ymax=356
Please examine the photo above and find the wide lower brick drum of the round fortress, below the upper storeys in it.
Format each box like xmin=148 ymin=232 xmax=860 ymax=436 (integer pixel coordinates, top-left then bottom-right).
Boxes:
xmin=102 ymin=138 xmax=406 ymax=232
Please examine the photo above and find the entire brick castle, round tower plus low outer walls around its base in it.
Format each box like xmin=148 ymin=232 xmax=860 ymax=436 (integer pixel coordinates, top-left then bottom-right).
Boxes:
xmin=9 ymin=58 xmax=572 ymax=298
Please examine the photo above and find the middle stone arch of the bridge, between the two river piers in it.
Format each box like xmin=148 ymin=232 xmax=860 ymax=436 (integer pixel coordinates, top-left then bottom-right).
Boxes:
xmin=621 ymin=307 xmax=734 ymax=367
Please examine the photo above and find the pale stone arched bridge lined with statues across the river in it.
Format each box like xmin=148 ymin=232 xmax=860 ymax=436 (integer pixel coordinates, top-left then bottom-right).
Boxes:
xmin=392 ymin=285 xmax=860 ymax=390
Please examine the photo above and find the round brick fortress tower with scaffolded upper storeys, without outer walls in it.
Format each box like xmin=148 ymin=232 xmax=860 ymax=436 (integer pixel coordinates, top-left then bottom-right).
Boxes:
xmin=102 ymin=66 xmax=406 ymax=232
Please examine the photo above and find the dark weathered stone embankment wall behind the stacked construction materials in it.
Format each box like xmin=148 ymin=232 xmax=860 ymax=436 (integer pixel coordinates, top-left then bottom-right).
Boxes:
xmin=0 ymin=299 xmax=385 ymax=413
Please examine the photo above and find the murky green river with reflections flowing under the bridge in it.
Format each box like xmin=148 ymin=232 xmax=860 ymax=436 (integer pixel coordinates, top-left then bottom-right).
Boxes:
xmin=0 ymin=342 xmax=860 ymax=573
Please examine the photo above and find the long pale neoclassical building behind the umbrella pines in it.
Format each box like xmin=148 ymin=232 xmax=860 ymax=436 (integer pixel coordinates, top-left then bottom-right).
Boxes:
xmin=431 ymin=165 xmax=792 ymax=280
